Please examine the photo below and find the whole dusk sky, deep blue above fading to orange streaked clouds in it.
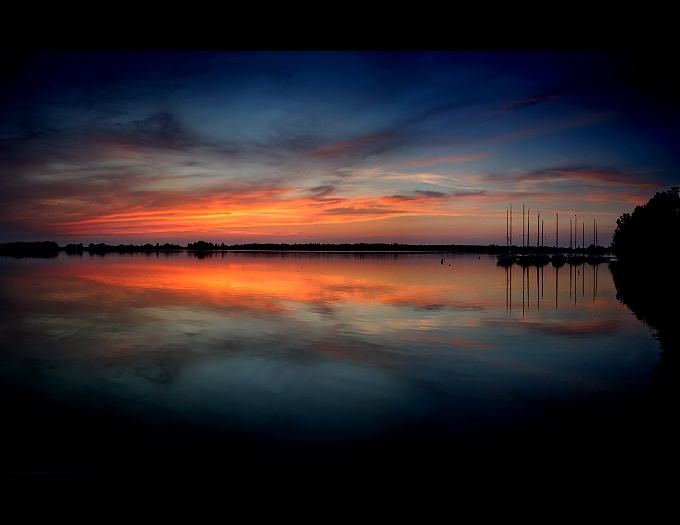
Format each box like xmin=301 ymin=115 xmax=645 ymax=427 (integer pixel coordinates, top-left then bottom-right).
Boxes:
xmin=0 ymin=51 xmax=680 ymax=246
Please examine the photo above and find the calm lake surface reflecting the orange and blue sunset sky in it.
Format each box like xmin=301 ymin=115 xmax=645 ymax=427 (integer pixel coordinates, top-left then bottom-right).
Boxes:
xmin=0 ymin=252 xmax=660 ymax=470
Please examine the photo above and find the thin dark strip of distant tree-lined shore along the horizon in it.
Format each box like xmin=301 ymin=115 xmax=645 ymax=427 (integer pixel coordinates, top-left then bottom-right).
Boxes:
xmin=0 ymin=241 xmax=608 ymax=257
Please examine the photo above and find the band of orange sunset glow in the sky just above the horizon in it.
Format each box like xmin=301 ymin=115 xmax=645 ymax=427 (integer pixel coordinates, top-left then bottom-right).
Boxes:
xmin=7 ymin=168 xmax=641 ymax=244
